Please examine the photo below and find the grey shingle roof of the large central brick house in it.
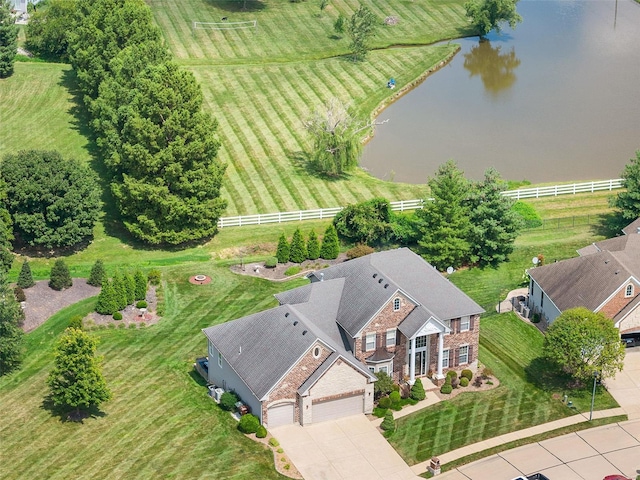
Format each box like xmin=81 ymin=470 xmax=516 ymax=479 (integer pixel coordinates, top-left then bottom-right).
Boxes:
xmin=203 ymin=248 xmax=484 ymax=399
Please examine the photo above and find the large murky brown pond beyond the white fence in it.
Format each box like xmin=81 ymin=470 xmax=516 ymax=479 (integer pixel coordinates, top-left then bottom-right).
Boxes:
xmin=361 ymin=0 xmax=640 ymax=183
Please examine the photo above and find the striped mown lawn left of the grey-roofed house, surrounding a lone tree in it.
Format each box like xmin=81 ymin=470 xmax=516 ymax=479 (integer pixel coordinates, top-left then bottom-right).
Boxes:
xmin=0 ymin=264 xmax=310 ymax=479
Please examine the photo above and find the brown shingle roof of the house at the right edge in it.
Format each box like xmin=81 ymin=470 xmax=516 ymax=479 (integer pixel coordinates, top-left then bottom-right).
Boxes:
xmin=528 ymin=219 xmax=640 ymax=318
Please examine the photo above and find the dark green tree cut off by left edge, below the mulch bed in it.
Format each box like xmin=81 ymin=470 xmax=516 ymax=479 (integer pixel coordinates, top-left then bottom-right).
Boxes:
xmin=0 ymin=272 xmax=24 ymax=376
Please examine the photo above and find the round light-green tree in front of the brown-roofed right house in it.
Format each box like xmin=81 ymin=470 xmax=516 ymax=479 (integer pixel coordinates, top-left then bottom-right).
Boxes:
xmin=544 ymin=307 xmax=625 ymax=382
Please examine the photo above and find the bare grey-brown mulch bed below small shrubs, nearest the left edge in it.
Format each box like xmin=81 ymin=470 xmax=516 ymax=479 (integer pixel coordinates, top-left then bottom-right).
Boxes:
xmin=22 ymin=278 xmax=100 ymax=332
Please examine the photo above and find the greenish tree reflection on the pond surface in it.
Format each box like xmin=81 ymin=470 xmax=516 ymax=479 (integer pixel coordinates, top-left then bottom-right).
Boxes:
xmin=464 ymin=39 xmax=520 ymax=99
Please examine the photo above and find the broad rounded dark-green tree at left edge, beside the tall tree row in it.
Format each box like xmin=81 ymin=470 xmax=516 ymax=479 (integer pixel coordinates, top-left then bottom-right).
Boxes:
xmin=0 ymin=150 xmax=100 ymax=248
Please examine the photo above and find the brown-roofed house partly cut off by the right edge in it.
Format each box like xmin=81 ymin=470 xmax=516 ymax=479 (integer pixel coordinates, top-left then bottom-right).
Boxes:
xmin=528 ymin=219 xmax=640 ymax=333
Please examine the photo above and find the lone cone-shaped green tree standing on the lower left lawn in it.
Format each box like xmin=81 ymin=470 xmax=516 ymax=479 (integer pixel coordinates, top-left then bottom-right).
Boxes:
xmin=47 ymin=328 xmax=111 ymax=414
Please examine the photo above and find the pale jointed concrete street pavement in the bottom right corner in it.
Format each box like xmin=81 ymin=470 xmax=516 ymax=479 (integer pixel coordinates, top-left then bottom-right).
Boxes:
xmin=438 ymin=420 xmax=640 ymax=480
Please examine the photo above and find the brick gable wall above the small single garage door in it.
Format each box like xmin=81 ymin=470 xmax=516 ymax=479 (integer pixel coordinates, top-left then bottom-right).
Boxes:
xmin=262 ymin=342 xmax=331 ymax=424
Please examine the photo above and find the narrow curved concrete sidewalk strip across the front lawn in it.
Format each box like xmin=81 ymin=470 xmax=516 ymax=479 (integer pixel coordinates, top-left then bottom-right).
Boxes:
xmin=411 ymin=408 xmax=626 ymax=475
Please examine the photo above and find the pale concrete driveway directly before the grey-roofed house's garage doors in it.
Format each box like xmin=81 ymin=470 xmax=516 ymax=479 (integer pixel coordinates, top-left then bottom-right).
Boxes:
xmin=271 ymin=415 xmax=419 ymax=480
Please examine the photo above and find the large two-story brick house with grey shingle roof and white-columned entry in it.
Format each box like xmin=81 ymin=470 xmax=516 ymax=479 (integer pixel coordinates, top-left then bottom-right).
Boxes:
xmin=203 ymin=248 xmax=483 ymax=428
